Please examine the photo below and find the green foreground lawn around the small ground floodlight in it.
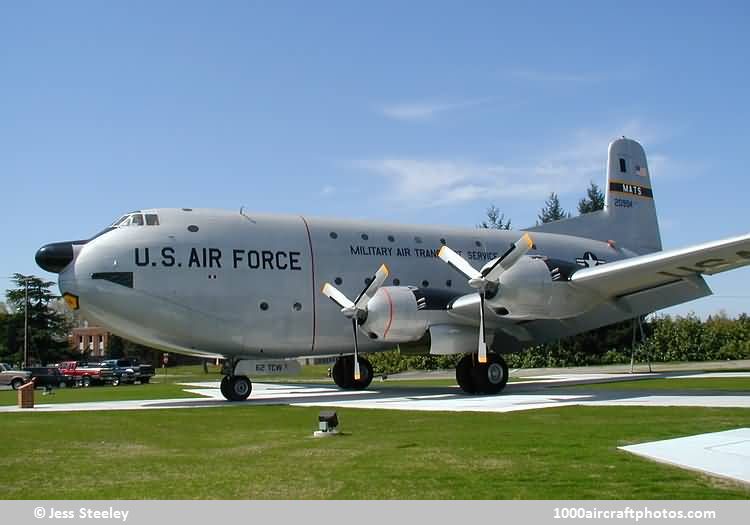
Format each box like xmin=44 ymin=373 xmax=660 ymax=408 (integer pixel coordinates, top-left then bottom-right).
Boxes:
xmin=0 ymin=405 xmax=750 ymax=499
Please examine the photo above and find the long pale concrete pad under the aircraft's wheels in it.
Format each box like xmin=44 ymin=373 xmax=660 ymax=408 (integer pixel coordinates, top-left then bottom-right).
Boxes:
xmin=0 ymin=374 xmax=750 ymax=413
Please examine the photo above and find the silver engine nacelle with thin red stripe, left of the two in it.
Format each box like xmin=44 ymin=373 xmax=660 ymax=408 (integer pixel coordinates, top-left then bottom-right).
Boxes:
xmin=360 ymin=286 xmax=428 ymax=343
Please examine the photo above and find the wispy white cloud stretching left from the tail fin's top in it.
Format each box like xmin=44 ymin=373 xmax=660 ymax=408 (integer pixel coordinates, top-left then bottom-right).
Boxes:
xmin=358 ymin=120 xmax=669 ymax=207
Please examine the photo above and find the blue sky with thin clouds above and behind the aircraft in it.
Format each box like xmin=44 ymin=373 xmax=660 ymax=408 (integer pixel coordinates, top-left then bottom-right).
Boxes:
xmin=0 ymin=1 xmax=750 ymax=315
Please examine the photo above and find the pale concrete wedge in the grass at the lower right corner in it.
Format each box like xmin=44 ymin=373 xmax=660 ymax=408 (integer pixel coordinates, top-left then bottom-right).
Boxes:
xmin=618 ymin=428 xmax=750 ymax=484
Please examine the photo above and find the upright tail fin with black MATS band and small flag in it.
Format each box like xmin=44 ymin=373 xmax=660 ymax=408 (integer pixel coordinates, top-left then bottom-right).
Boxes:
xmin=528 ymin=137 xmax=662 ymax=255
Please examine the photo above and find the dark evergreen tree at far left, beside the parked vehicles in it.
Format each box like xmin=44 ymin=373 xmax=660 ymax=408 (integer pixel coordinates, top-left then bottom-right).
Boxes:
xmin=5 ymin=273 xmax=71 ymax=364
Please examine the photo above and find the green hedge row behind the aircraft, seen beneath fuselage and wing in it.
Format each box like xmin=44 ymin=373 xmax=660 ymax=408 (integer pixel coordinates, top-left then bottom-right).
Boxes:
xmin=368 ymin=314 xmax=750 ymax=374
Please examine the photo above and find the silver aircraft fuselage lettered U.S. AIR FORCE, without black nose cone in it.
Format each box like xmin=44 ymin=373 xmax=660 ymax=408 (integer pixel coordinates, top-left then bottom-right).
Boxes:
xmin=54 ymin=209 xmax=635 ymax=358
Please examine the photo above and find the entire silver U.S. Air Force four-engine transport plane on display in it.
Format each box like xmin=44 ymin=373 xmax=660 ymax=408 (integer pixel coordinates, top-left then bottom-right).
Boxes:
xmin=36 ymin=138 xmax=750 ymax=401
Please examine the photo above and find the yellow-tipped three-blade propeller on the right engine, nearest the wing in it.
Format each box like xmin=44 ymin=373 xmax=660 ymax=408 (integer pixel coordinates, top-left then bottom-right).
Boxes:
xmin=438 ymin=233 xmax=534 ymax=363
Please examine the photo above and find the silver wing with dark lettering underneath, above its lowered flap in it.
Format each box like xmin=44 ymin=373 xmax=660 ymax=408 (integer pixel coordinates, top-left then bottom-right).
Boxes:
xmin=571 ymin=234 xmax=750 ymax=297
